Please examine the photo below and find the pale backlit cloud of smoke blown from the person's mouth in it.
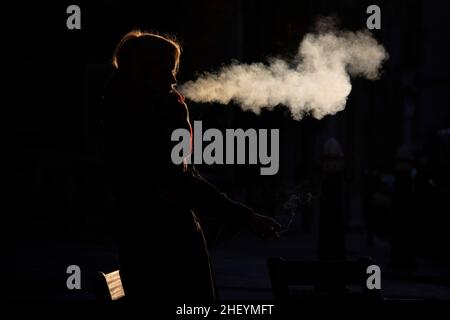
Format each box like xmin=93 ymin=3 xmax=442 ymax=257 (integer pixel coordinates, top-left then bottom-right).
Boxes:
xmin=180 ymin=26 xmax=387 ymax=120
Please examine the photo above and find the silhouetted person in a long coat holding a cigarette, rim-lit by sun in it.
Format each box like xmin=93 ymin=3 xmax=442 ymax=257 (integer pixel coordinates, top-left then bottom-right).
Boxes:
xmin=105 ymin=31 xmax=279 ymax=302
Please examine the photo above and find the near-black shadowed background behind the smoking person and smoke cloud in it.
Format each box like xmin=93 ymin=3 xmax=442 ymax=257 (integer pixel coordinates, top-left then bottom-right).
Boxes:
xmin=0 ymin=0 xmax=450 ymax=299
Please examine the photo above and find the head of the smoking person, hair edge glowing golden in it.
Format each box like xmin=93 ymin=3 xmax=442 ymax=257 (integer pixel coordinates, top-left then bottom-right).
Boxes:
xmin=112 ymin=30 xmax=181 ymax=93
